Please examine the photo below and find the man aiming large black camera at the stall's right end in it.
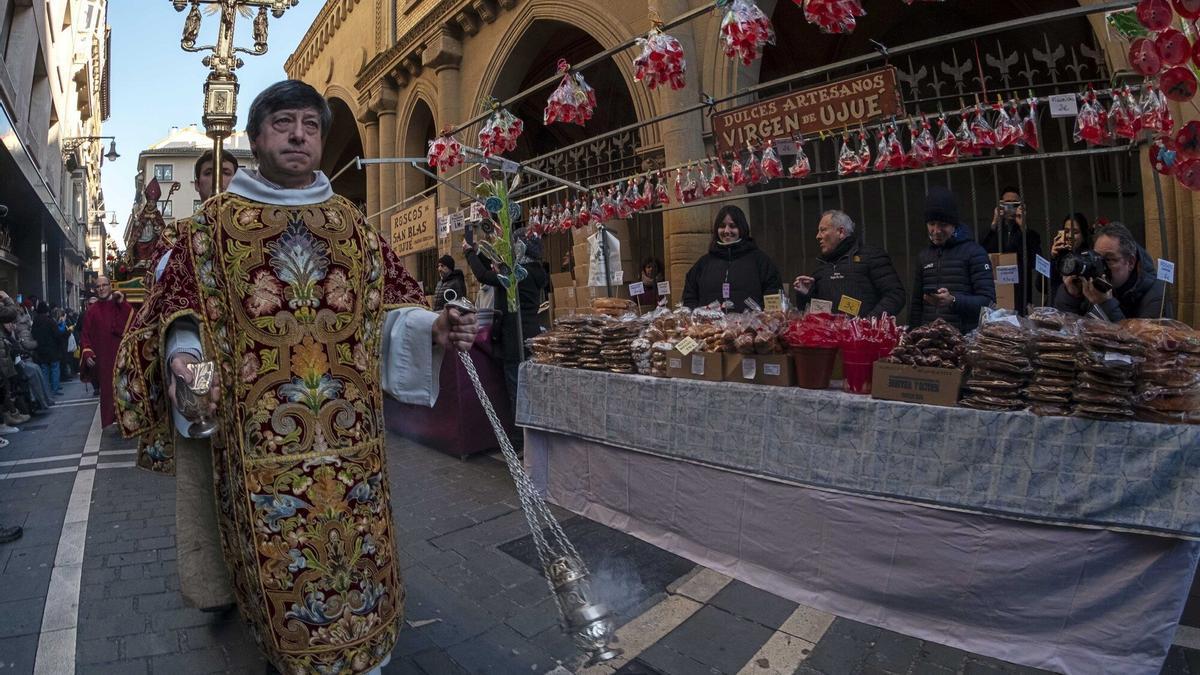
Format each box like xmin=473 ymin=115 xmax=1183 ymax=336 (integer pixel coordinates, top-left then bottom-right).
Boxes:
xmin=1054 ymin=222 xmax=1172 ymax=322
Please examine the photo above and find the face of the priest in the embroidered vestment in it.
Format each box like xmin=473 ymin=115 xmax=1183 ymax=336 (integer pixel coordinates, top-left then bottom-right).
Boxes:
xmin=250 ymin=108 xmax=322 ymax=187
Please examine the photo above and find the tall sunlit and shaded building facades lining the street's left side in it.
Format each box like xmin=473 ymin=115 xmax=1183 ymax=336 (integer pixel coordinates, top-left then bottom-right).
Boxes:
xmin=0 ymin=0 xmax=109 ymax=306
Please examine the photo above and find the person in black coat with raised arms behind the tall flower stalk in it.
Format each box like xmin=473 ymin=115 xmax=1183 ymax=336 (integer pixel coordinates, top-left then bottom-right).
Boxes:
xmin=462 ymin=228 xmax=550 ymax=401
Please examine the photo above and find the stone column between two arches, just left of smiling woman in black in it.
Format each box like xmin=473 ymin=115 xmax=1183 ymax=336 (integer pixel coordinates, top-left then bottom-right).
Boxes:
xmin=658 ymin=0 xmax=713 ymax=300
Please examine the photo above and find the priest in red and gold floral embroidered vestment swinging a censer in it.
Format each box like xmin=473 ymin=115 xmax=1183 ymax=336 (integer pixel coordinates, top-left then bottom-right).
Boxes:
xmin=115 ymin=80 xmax=476 ymax=674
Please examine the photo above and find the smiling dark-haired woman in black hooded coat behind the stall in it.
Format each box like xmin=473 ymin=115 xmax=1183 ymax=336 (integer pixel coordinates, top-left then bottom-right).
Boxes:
xmin=683 ymin=207 xmax=782 ymax=311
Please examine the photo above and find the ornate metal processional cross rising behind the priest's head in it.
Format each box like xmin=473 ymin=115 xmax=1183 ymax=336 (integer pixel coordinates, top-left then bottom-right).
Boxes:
xmin=172 ymin=0 xmax=300 ymax=195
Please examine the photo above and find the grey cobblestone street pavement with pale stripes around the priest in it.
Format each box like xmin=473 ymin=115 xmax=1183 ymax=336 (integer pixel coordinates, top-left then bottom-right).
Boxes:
xmin=0 ymin=383 xmax=1200 ymax=675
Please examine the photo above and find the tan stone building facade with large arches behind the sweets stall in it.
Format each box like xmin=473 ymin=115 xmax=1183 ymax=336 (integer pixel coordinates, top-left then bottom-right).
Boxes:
xmin=286 ymin=0 xmax=1200 ymax=321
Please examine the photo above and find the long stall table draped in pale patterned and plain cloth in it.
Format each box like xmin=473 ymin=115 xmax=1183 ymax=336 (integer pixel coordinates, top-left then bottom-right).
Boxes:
xmin=517 ymin=364 xmax=1200 ymax=674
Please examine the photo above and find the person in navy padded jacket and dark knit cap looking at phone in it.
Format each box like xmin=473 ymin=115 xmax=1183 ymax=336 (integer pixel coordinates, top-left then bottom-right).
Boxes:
xmin=908 ymin=186 xmax=996 ymax=333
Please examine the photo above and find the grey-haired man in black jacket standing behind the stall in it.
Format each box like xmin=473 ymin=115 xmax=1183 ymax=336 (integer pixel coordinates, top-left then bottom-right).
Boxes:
xmin=792 ymin=210 xmax=905 ymax=317
